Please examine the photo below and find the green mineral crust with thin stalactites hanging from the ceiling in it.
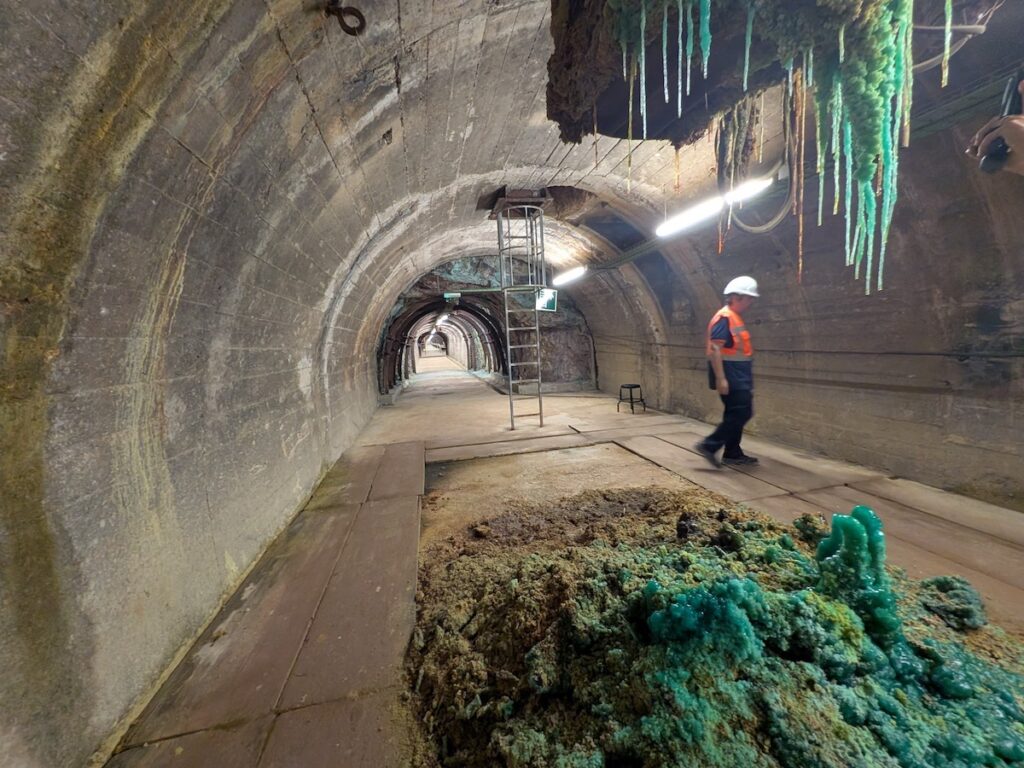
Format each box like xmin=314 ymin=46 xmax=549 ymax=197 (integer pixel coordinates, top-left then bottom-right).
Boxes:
xmin=607 ymin=0 xmax=929 ymax=293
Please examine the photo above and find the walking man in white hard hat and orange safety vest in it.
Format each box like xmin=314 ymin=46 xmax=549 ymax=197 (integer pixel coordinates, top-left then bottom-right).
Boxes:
xmin=696 ymin=275 xmax=759 ymax=467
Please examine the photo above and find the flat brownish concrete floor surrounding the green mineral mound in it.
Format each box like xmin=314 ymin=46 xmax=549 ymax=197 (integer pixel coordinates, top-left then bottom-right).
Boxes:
xmin=108 ymin=358 xmax=1024 ymax=768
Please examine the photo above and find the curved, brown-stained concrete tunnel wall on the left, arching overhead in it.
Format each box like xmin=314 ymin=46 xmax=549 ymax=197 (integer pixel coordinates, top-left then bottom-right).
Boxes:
xmin=0 ymin=1 xmax=663 ymax=767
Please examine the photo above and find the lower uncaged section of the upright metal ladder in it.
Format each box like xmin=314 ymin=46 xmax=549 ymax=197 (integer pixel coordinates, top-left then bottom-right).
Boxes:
xmin=502 ymin=288 xmax=544 ymax=429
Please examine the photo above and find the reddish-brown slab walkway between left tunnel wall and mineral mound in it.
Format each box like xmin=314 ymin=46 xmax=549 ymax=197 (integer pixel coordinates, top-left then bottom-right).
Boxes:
xmin=108 ymin=441 xmax=424 ymax=768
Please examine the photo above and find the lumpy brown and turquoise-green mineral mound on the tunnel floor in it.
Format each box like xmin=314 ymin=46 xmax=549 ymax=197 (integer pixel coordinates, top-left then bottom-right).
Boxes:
xmin=409 ymin=488 xmax=1024 ymax=768
